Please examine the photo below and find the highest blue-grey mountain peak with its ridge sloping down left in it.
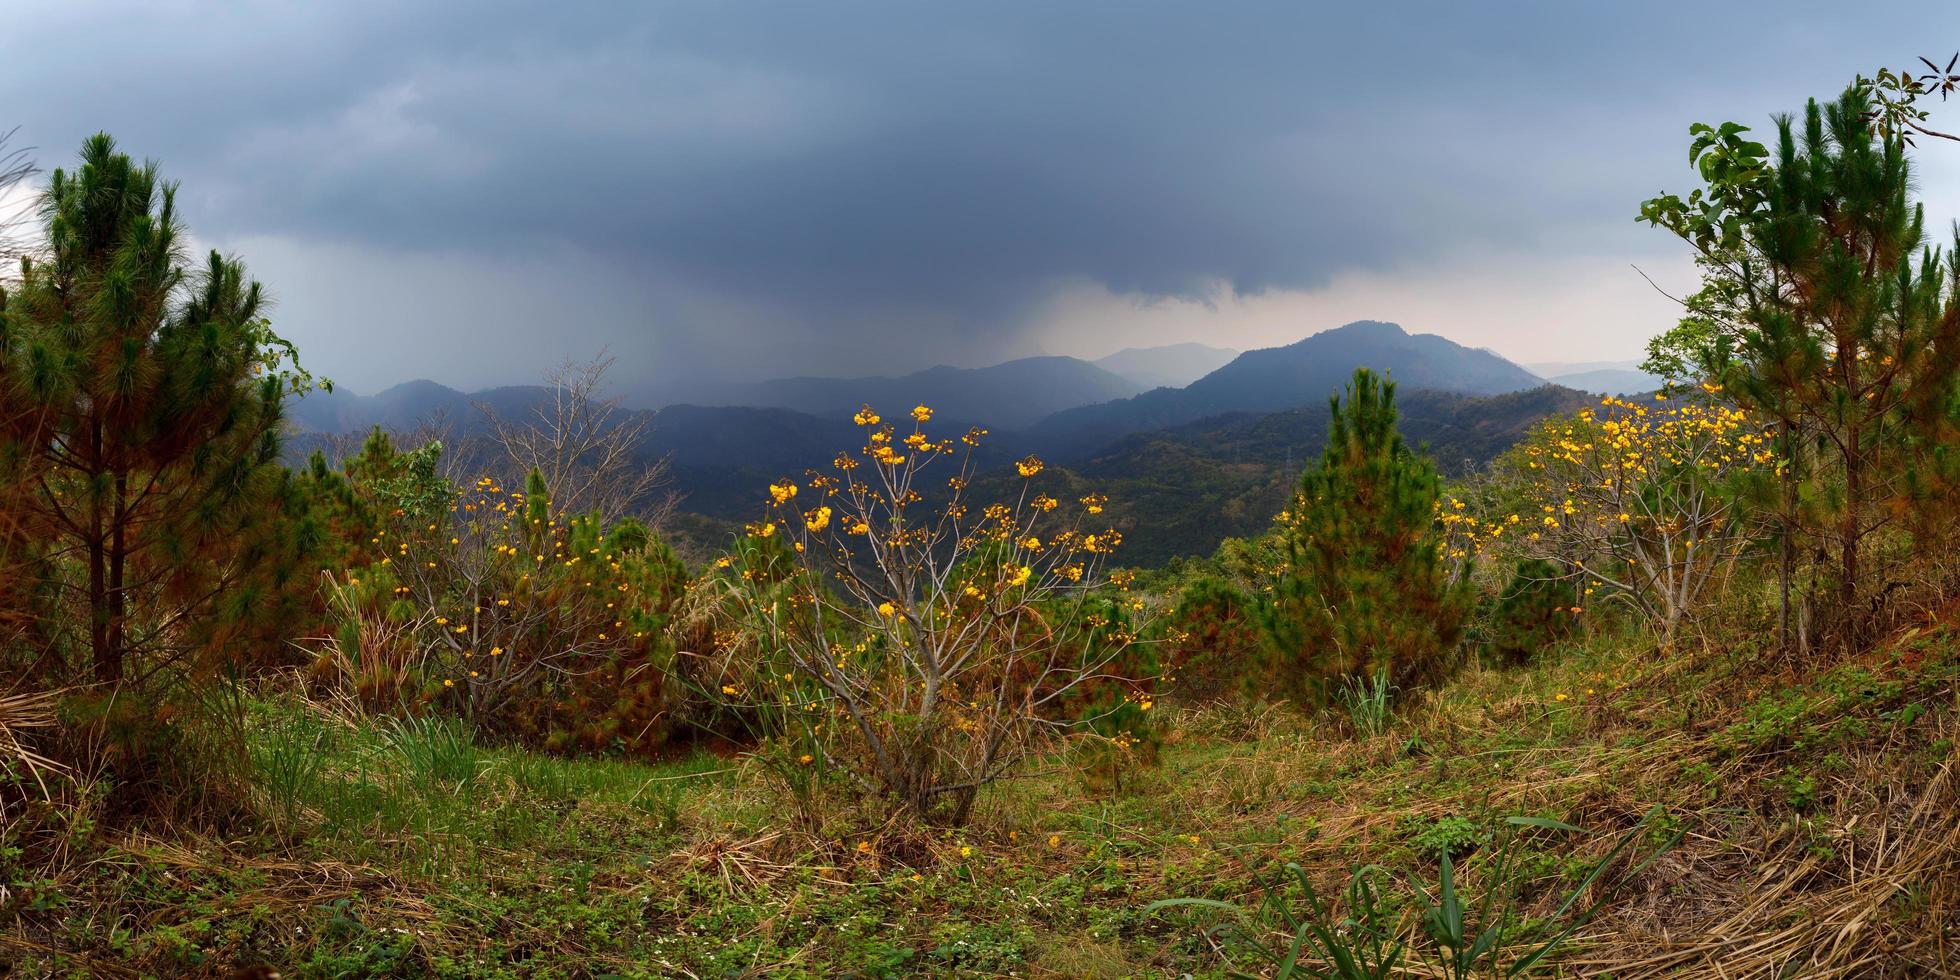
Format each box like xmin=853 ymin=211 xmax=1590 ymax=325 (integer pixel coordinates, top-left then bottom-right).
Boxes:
xmin=1029 ymin=319 xmax=1544 ymax=457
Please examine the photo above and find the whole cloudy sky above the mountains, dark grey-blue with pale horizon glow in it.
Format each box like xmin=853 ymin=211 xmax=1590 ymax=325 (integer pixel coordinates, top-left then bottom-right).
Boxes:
xmin=0 ymin=0 xmax=1960 ymax=402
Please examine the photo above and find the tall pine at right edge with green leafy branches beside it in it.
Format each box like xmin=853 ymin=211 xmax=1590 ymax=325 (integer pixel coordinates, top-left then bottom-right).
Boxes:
xmin=1642 ymin=86 xmax=1960 ymax=643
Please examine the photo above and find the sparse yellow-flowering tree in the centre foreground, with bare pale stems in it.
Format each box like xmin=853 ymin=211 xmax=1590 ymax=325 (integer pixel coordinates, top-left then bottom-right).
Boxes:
xmin=723 ymin=406 xmax=1141 ymax=823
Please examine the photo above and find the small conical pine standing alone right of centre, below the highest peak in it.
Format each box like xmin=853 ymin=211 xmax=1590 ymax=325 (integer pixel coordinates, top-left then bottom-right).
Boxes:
xmin=1258 ymin=368 xmax=1470 ymax=696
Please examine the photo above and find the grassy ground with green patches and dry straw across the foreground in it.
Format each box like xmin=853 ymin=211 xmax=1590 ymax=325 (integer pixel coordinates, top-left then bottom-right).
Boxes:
xmin=0 ymin=623 xmax=1960 ymax=980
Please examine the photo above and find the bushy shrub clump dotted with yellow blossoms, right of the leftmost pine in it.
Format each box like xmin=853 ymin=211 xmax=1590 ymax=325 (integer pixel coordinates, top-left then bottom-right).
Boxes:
xmin=316 ymin=441 xmax=686 ymax=755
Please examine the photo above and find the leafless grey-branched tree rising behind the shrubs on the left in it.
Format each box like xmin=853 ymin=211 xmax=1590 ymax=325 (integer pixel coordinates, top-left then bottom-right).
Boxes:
xmin=476 ymin=355 xmax=676 ymax=527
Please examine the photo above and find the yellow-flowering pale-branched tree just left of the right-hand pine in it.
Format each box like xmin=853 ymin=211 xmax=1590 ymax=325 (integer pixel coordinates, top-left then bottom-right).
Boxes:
xmin=1482 ymin=390 xmax=1776 ymax=637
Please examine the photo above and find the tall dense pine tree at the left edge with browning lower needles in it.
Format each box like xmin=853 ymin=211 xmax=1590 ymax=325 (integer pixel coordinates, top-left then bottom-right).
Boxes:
xmin=0 ymin=135 xmax=318 ymax=684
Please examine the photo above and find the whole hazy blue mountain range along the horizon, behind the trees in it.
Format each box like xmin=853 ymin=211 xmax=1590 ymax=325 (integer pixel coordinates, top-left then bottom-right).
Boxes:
xmin=290 ymin=321 xmax=1650 ymax=564
